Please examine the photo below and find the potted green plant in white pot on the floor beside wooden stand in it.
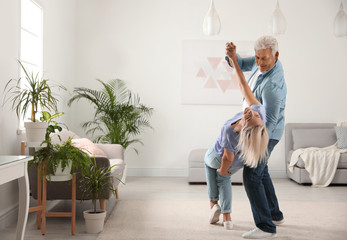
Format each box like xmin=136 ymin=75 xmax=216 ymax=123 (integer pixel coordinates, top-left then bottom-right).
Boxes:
xmin=80 ymin=158 xmax=115 ymax=233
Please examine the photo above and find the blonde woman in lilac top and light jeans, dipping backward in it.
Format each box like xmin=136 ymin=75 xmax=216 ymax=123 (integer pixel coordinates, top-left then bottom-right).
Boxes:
xmin=205 ymin=43 xmax=269 ymax=230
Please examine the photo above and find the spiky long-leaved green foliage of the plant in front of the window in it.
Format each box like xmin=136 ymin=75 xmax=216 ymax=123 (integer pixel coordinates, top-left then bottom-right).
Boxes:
xmin=4 ymin=61 xmax=66 ymax=122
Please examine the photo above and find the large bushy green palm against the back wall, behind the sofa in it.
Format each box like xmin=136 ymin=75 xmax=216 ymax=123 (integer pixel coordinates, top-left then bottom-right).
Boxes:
xmin=68 ymin=79 xmax=153 ymax=152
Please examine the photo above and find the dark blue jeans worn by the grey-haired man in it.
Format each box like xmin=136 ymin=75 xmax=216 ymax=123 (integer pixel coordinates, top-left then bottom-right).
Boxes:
xmin=243 ymin=139 xmax=283 ymax=233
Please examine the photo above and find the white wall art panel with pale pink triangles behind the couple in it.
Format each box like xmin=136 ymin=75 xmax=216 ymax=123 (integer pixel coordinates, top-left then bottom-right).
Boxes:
xmin=181 ymin=40 xmax=254 ymax=105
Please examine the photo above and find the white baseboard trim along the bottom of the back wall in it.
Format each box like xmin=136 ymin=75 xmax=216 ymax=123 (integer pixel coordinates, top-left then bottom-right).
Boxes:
xmin=127 ymin=167 xmax=287 ymax=178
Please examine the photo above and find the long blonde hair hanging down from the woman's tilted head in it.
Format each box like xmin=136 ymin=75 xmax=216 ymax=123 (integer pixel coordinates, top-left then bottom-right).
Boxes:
xmin=237 ymin=124 xmax=269 ymax=168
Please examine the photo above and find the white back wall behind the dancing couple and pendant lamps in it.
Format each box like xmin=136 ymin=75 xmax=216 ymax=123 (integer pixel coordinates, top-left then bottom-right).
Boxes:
xmin=71 ymin=0 xmax=347 ymax=177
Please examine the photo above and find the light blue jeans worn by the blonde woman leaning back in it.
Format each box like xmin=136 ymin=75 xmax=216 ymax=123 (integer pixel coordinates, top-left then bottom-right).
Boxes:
xmin=205 ymin=146 xmax=242 ymax=213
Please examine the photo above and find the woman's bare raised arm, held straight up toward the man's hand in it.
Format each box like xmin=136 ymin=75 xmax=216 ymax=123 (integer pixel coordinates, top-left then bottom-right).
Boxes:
xmin=226 ymin=43 xmax=260 ymax=106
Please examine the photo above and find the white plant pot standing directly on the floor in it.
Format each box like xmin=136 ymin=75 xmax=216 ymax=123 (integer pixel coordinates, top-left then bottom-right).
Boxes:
xmin=83 ymin=210 xmax=106 ymax=233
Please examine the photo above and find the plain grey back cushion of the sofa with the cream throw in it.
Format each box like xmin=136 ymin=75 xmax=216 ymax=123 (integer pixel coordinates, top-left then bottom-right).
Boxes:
xmin=292 ymin=128 xmax=337 ymax=150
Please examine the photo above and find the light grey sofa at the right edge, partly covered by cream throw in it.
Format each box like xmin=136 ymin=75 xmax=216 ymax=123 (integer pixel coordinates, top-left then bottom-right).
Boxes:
xmin=285 ymin=123 xmax=347 ymax=184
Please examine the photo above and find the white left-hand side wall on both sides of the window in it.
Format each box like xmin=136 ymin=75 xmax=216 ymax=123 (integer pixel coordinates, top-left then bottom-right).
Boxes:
xmin=0 ymin=0 xmax=76 ymax=231
